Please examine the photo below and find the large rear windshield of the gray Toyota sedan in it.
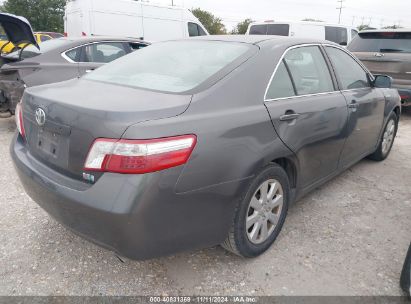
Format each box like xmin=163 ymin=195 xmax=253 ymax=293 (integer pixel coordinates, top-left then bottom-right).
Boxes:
xmin=84 ymin=41 xmax=252 ymax=93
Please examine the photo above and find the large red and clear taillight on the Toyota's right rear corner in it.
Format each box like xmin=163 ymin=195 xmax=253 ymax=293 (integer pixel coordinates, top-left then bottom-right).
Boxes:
xmin=84 ymin=135 xmax=197 ymax=174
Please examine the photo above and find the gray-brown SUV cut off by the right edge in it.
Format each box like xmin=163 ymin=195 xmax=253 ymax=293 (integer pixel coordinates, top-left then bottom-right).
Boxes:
xmin=348 ymin=29 xmax=411 ymax=106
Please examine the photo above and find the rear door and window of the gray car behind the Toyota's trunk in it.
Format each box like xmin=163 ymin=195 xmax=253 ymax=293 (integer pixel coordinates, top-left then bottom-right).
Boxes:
xmin=79 ymin=41 xmax=128 ymax=75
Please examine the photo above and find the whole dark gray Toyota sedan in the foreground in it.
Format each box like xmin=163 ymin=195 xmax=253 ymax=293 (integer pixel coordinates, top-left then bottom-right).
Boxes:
xmin=11 ymin=36 xmax=400 ymax=259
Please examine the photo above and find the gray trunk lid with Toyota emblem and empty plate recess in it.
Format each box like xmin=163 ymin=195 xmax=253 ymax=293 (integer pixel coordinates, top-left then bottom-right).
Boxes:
xmin=23 ymin=79 xmax=191 ymax=179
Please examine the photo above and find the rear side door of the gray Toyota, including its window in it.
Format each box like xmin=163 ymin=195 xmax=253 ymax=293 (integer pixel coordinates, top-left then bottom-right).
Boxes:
xmin=265 ymin=45 xmax=348 ymax=188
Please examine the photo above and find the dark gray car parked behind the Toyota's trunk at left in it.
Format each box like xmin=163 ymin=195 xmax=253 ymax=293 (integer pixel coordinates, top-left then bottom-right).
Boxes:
xmin=0 ymin=37 xmax=148 ymax=114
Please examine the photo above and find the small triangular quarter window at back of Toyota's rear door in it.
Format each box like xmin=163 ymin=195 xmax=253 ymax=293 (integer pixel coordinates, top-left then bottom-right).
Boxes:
xmin=265 ymin=61 xmax=295 ymax=99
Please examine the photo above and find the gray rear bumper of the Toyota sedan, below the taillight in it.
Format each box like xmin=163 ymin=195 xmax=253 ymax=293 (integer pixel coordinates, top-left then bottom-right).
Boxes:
xmin=10 ymin=135 xmax=248 ymax=260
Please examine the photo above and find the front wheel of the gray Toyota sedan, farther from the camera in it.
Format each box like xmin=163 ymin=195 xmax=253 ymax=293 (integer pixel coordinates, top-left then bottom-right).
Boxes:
xmin=368 ymin=112 xmax=398 ymax=161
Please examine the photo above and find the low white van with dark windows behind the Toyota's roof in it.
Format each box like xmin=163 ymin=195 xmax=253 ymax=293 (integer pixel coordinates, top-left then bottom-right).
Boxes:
xmin=247 ymin=21 xmax=358 ymax=45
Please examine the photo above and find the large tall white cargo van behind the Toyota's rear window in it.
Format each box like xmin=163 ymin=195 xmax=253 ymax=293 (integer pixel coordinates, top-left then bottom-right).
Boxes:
xmin=64 ymin=0 xmax=208 ymax=41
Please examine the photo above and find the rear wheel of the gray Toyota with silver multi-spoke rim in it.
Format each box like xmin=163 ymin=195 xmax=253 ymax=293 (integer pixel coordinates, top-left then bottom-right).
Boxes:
xmin=221 ymin=164 xmax=290 ymax=258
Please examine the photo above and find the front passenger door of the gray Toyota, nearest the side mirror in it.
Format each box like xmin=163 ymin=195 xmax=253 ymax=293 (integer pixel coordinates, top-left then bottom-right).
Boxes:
xmin=325 ymin=46 xmax=385 ymax=167
